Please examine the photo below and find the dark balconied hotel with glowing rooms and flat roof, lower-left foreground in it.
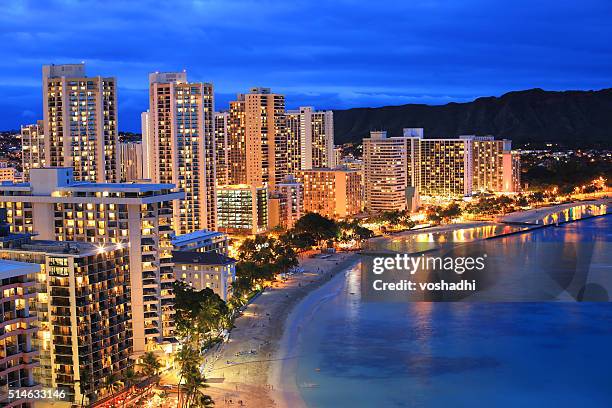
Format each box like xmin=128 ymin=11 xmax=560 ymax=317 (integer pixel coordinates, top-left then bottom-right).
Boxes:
xmin=0 ymin=229 xmax=133 ymax=408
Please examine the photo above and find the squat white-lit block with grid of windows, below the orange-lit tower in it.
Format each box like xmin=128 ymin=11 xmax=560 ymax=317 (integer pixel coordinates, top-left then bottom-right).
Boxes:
xmin=217 ymin=184 xmax=268 ymax=234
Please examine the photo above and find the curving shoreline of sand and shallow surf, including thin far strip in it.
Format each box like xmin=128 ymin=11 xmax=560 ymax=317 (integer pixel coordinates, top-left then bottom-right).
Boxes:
xmin=201 ymin=198 xmax=610 ymax=408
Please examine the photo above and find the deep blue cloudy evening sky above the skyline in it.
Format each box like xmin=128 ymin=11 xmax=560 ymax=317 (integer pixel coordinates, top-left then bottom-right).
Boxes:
xmin=0 ymin=0 xmax=612 ymax=132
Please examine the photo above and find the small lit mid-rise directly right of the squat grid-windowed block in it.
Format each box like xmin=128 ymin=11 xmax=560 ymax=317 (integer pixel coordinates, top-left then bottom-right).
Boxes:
xmin=268 ymin=176 xmax=304 ymax=229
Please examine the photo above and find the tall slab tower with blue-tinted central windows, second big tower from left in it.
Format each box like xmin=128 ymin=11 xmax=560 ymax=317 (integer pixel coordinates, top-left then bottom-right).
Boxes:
xmin=148 ymin=72 xmax=217 ymax=234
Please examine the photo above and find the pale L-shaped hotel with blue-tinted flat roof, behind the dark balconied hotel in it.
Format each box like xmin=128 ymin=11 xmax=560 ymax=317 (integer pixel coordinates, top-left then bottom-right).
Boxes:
xmin=0 ymin=168 xmax=183 ymax=354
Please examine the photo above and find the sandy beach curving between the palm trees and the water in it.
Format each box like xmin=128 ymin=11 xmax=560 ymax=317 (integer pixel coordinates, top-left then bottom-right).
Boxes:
xmin=201 ymin=252 xmax=357 ymax=408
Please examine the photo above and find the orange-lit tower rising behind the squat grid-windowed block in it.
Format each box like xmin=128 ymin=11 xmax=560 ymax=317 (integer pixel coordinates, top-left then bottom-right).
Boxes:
xmin=228 ymin=88 xmax=288 ymax=191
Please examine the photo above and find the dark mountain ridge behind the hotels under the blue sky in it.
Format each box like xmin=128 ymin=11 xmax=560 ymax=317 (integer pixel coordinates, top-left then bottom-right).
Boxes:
xmin=334 ymin=88 xmax=612 ymax=148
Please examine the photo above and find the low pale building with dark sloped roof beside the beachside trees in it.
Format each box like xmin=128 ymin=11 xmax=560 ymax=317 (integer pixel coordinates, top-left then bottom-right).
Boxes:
xmin=172 ymin=251 xmax=236 ymax=301
